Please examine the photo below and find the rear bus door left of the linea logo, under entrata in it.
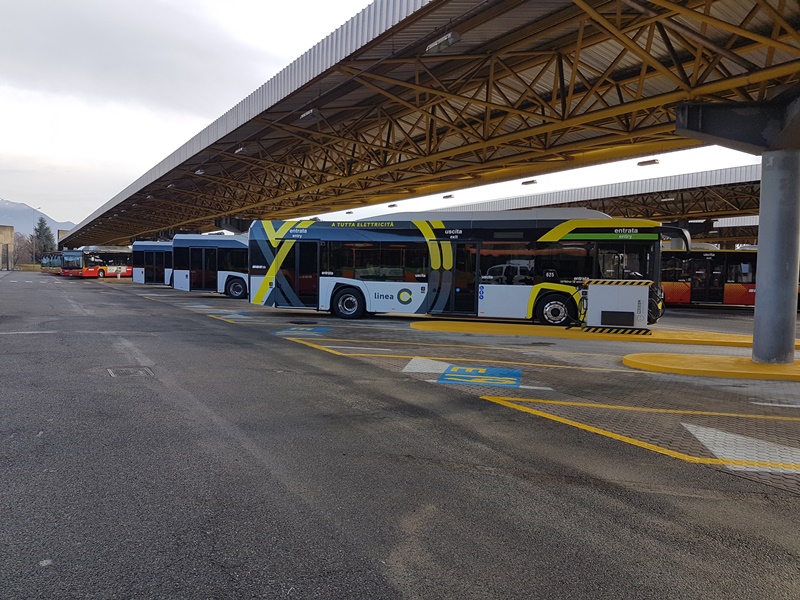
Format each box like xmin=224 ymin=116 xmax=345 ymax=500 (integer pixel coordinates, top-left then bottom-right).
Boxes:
xmin=275 ymin=241 xmax=319 ymax=308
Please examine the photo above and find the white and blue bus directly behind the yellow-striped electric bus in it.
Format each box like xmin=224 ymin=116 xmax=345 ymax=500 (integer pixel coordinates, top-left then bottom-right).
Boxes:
xmin=172 ymin=233 xmax=248 ymax=298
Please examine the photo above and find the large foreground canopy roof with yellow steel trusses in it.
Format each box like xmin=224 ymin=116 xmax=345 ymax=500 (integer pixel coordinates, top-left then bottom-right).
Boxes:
xmin=62 ymin=0 xmax=800 ymax=245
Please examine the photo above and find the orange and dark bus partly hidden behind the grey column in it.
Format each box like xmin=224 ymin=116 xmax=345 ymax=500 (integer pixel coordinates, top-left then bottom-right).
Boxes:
xmin=661 ymin=244 xmax=757 ymax=306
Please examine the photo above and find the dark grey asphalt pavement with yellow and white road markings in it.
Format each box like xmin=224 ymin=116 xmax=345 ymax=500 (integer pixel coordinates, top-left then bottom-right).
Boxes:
xmin=0 ymin=272 xmax=800 ymax=600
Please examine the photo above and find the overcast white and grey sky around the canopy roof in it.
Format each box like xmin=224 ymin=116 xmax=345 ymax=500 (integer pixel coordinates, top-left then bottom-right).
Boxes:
xmin=0 ymin=0 xmax=758 ymax=223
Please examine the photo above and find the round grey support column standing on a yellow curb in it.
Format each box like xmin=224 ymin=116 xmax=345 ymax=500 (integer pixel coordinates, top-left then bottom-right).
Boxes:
xmin=753 ymin=150 xmax=800 ymax=364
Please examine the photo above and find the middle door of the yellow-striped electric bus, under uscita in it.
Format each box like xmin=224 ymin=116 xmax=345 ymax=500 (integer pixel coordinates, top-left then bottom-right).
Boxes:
xmin=428 ymin=240 xmax=478 ymax=315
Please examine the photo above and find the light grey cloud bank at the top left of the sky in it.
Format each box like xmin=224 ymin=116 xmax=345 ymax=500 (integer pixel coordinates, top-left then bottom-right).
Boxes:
xmin=0 ymin=0 xmax=285 ymax=119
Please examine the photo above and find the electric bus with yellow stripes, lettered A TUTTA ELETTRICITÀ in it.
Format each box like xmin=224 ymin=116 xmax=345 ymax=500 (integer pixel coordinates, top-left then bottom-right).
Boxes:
xmin=249 ymin=209 xmax=690 ymax=325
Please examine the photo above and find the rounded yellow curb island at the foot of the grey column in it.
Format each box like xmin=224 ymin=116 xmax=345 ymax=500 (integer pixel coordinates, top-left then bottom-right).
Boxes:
xmin=622 ymin=353 xmax=800 ymax=381
